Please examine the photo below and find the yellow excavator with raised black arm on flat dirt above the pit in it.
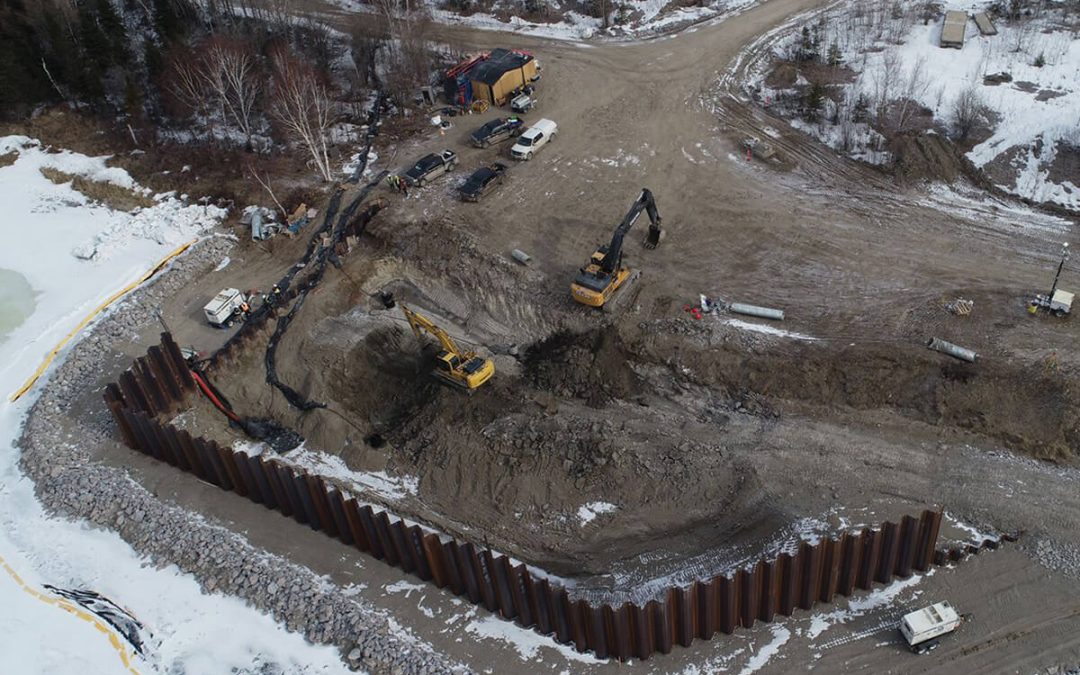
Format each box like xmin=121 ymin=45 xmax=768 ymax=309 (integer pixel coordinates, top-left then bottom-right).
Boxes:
xmin=570 ymin=188 xmax=664 ymax=310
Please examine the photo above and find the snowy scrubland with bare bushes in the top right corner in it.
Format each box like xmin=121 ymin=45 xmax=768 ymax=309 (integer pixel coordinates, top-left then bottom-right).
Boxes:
xmin=752 ymin=0 xmax=1080 ymax=210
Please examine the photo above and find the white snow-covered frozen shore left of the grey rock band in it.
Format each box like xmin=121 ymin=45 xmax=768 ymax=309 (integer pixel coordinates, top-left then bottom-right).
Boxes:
xmin=0 ymin=137 xmax=346 ymax=675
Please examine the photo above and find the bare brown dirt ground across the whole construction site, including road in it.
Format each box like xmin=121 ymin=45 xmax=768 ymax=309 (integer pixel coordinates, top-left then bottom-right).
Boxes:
xmin=101 ymin=0 xmax=1080 ymax=673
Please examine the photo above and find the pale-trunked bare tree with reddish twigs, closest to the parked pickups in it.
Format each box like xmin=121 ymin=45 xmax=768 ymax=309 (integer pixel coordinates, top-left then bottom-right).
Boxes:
xmin=273 ymin=49 xmax=335 ymax=181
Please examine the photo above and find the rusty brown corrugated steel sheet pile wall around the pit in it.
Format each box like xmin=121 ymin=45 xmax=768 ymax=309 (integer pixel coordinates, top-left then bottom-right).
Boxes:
xmin=105 ymin=334 xmax=942 ymax=660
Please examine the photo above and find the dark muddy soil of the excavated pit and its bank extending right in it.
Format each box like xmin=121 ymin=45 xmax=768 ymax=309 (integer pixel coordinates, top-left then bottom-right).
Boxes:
xmin=177 ymin=193 xmax=1080 ymax=590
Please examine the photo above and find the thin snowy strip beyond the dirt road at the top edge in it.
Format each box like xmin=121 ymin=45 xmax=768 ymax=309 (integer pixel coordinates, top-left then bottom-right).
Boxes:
xmin=333 ymin=0 xmax=762 ymax=41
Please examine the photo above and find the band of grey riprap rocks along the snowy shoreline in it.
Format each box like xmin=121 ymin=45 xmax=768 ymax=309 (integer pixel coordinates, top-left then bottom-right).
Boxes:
xmin=19 ymin=238 xmax=468 ymax=674
